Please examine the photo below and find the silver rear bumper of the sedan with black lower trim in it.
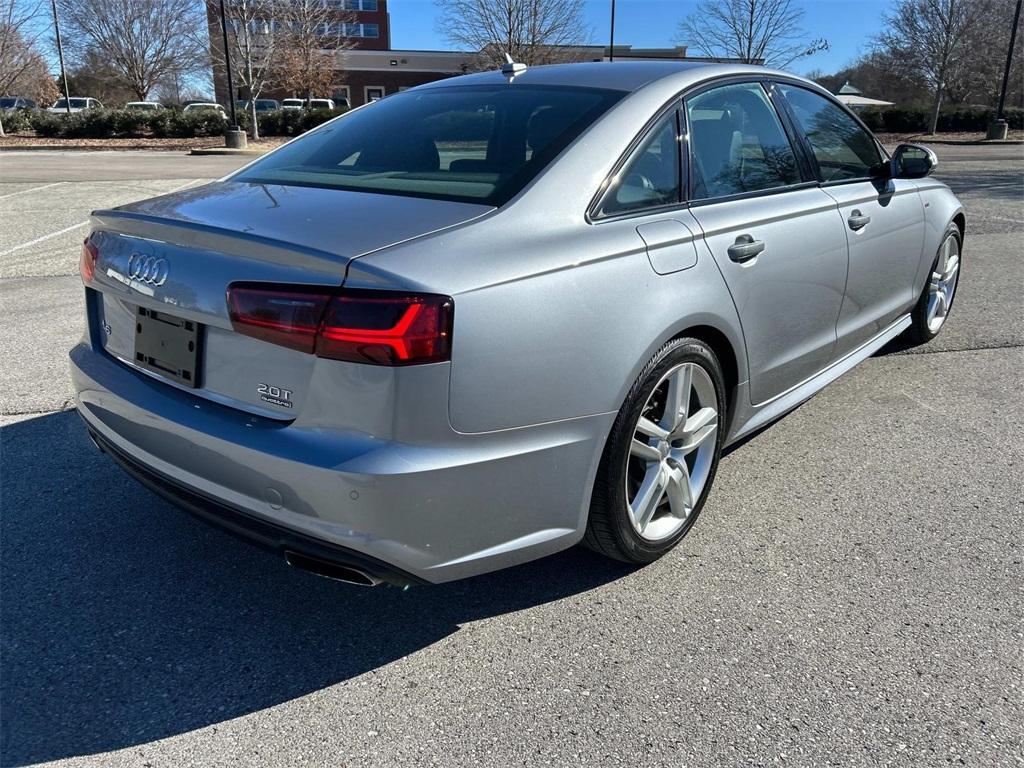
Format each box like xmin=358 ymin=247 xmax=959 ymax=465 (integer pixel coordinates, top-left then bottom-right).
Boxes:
xmin=71 ymin=343 xmax=614 ymax=585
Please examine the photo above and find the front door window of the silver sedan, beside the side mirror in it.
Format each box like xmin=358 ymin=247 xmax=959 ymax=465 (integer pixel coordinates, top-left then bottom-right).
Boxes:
xmin=779 ymin=85 xmax=881 ymax=181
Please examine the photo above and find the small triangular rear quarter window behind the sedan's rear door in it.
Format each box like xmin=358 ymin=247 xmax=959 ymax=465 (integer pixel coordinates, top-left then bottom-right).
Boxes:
xmin=601 ymin=111 xmax=680 ymax=215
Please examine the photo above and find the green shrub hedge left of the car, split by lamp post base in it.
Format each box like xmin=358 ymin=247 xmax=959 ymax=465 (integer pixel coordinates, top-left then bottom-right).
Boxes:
xmin=12 ymin=110 xmax=345 ymax=138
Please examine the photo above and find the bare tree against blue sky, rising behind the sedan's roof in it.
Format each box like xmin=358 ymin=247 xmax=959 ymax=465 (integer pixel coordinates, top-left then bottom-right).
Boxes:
xmin=679 ymin=0 xmax=828 ymax=68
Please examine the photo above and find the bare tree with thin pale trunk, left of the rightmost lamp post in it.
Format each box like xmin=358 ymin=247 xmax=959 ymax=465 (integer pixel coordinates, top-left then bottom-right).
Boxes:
xmin=876 ymin=0 xmax=989 ymax=133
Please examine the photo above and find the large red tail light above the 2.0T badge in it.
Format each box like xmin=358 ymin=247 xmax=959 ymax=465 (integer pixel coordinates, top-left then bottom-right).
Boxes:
xmin=227 ymin=285 xmax=453 ymax=366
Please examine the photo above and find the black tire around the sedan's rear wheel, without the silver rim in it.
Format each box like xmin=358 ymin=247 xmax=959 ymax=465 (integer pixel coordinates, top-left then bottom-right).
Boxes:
xmin=600 ymin=339 xmax=727 ymax=563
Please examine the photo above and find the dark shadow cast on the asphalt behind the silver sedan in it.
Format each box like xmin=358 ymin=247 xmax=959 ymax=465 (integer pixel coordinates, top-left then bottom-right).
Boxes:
xmin=0 ymin=412 xmax=631 ymax=765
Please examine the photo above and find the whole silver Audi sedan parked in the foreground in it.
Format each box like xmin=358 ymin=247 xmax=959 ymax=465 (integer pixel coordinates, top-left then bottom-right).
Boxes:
xmin=71 ymin=62 xmax=965 ymax=585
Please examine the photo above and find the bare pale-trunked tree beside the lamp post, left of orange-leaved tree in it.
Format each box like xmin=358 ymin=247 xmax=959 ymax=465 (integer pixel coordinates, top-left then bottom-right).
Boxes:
xmin=211 ymin=0 xmax=291 ymax=139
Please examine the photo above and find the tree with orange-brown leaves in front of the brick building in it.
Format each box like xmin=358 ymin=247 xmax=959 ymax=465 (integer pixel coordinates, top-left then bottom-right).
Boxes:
xmin=278 ymin=0 xmax=355 ymax=99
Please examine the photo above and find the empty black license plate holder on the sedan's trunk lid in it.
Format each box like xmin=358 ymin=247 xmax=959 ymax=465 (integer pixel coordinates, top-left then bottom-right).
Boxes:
xmin=135 ymin=306 xmax=202 ymax=388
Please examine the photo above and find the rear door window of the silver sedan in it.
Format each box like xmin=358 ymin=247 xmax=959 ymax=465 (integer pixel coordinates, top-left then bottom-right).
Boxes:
xmin=686 ymin=83 xmax=801 ymax=200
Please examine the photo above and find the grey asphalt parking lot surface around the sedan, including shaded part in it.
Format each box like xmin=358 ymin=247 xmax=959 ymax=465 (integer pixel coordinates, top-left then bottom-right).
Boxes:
xmin=0 ymin=146 xmax=1024 ymax=767
